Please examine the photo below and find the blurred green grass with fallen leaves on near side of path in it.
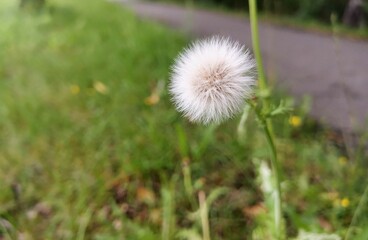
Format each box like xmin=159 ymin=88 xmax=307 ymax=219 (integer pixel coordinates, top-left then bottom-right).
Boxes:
xmin=0 ymin=0 xmax=367 ymax=239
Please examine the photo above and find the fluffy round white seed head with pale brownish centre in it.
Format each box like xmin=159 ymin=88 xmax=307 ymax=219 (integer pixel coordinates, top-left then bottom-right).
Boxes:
xmin=169 ymin=37 xmax=255 ymax=124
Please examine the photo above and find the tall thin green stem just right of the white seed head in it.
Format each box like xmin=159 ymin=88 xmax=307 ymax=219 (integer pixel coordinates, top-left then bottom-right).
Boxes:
xmin=249 ymin=0 xmax=282 ymax=239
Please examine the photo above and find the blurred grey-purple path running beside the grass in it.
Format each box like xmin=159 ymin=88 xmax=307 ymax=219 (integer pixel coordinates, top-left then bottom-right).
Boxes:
xmin=124 ymin=1 xmax=368 ymax=132
